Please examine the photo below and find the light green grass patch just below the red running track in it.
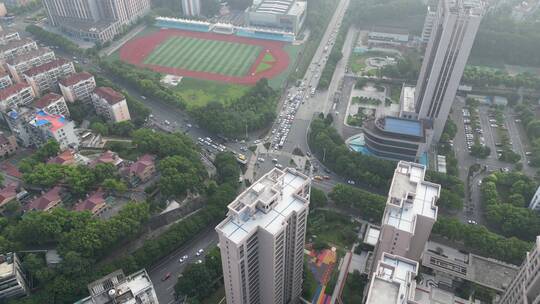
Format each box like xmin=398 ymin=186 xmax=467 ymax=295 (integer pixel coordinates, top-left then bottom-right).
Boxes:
xmin=174 ymin=78 xmax=250 ymax=108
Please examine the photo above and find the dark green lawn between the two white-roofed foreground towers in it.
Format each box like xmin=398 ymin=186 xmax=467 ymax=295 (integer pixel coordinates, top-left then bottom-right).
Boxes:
xmin=307 ymin=210 xmax=359 ymax=249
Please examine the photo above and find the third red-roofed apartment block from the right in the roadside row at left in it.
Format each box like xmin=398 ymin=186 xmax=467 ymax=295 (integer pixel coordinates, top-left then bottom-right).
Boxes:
xmin=23 ymin=58 xmax=75 ymax=96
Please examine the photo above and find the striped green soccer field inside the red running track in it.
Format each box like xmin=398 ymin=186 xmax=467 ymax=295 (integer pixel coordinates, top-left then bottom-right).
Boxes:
xmin=144 ymin=36 xmax=262 ymax=76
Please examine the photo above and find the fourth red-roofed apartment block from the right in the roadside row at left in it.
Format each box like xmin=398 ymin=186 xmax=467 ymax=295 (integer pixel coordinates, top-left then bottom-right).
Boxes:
xmin=6 ymin=47 xmax=56 ymax=82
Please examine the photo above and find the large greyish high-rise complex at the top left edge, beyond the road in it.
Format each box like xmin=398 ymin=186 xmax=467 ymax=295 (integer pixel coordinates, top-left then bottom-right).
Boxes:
xmin=43 ymin=0 xmax=150 ymax=43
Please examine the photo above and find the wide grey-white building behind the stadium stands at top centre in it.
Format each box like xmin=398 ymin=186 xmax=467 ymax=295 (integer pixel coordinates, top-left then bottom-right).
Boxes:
xmin=245 ymin=0 xmax=307 ymax=34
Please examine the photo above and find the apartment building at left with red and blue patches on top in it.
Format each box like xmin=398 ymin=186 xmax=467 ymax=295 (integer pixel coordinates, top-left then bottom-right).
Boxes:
xmin=2 ymin=107 xmax=79 ymax=150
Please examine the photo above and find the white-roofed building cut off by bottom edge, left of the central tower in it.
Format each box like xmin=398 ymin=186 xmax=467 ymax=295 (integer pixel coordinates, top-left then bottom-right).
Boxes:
xmin=75 ymin=269 xmax=159 ymax=304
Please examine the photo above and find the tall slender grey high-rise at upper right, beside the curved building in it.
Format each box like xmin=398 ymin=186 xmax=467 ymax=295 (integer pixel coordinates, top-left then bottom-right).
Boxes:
xmin=415 ymin=0 xmax=484 ymax=143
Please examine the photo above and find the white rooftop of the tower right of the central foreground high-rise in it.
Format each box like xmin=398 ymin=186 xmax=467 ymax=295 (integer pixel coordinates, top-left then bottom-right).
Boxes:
xmin=383 ymin=161 xmax=441 ymax=232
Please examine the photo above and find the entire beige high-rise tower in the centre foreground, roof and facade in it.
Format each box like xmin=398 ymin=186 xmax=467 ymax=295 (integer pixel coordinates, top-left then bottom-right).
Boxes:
xmin=216 ymin=168 xmax=311 ymax=304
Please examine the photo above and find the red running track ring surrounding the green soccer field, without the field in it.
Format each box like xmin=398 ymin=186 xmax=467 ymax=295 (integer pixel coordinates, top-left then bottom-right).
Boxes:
xmin=116 ymin=29 xmax=290 ymax=85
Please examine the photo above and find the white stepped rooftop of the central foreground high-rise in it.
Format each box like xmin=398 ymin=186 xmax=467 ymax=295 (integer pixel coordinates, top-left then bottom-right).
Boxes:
xmin=216 ymin=168 xmax=310 ymax=243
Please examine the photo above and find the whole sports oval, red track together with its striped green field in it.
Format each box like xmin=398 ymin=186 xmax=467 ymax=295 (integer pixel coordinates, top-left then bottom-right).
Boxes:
xmin=119 ymin=29 xmax=290 ymax=85
